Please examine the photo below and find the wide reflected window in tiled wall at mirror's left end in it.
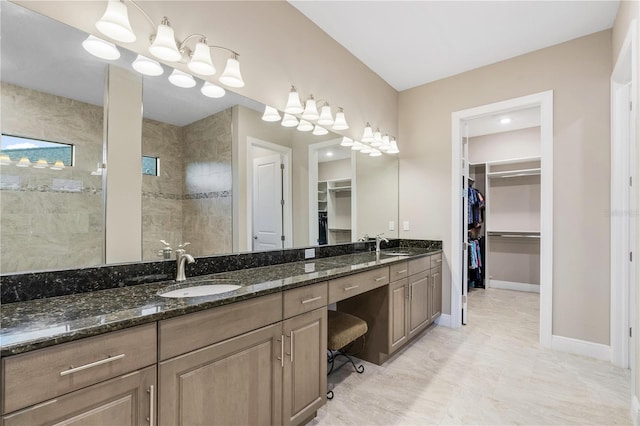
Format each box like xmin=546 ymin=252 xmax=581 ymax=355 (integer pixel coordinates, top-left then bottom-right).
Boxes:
xmin=0 ymin=134 xmax=74 ymax=166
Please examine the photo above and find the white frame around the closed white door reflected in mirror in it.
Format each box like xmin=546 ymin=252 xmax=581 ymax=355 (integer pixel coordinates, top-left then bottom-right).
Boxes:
xmin=246 ymin=136 xmax=293 ymax=250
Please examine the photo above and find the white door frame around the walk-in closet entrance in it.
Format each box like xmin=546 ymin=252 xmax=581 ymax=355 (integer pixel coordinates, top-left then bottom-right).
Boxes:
xmin=451 ymin=90 xmax=553 ymax=347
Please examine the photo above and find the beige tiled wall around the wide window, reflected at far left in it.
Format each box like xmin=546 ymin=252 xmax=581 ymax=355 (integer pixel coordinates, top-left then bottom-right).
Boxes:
xmin=0 ymin=83 xmax=104 ymax=273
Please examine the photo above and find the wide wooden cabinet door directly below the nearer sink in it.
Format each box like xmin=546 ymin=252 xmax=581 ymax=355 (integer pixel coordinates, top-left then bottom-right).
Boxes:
xmin=158 ymin=323 xmax=282 ymax=426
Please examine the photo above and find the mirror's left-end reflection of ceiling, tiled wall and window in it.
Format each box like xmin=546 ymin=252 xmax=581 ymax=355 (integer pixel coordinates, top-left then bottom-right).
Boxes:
xmin=0 ymin=2 xmax=105 ymax=273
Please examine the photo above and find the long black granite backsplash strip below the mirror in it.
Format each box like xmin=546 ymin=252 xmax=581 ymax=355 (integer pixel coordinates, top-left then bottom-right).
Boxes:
xmin=0 ymin=239 xmax=442 ymax=303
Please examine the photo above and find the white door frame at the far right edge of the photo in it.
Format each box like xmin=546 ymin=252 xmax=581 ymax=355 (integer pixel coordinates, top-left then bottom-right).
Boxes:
xmin=610 ymin=20 xmax=638 ymax=372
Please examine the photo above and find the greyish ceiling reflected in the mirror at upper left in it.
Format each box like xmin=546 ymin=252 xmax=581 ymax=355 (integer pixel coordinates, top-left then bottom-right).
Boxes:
xmin=0 ymin=1 xmax=264 ymax=126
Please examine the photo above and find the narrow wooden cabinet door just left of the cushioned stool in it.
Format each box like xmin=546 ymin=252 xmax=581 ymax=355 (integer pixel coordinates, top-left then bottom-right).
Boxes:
xmin=282 ymin=307 xmax=327 ymax=425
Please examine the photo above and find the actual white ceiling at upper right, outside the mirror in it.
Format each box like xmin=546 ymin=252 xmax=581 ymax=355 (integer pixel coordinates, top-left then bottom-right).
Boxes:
xmin=289 ymin=0 xmax=619 ymax=91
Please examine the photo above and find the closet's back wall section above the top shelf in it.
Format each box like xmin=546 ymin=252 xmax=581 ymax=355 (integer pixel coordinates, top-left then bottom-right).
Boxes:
xmin=469 ymin=127 xmax=540 ymax=164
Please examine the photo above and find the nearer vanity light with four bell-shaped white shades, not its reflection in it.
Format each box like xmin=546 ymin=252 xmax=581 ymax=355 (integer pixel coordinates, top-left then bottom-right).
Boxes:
xmin=96 ymin=0 xmax=244 ymax=87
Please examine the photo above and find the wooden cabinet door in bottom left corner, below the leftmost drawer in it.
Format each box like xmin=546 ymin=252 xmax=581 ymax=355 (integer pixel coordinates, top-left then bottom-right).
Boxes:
xmin=2 ymin=366 xmax=156 ymax=426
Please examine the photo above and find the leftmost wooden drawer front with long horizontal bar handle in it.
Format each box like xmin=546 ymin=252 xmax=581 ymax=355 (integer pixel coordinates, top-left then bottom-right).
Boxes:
xmin=2 ymin=323 xmax=157 ymax=413
